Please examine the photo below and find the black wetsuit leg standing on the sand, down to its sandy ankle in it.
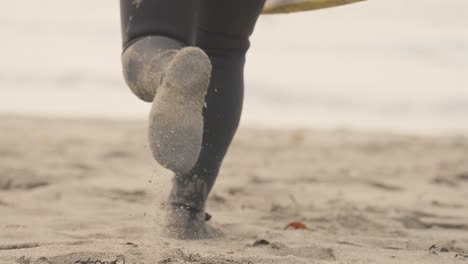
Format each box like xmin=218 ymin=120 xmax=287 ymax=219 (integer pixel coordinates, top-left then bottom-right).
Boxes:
xmin=171 ymin=0 xmax=264 ymax=234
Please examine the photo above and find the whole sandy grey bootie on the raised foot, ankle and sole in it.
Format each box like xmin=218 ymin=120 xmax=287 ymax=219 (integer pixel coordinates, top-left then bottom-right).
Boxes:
xmin=122 ymin=36 xmax=211 ymax=174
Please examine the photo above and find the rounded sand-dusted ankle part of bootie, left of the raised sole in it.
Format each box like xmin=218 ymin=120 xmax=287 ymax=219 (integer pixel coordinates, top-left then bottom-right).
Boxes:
xmin=122 ymin=36 xmax=183 ymax=102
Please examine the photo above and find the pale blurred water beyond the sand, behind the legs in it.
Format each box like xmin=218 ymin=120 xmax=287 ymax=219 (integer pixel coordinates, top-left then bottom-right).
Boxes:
xmin=0 ymin=0 xmax=468 ymax=132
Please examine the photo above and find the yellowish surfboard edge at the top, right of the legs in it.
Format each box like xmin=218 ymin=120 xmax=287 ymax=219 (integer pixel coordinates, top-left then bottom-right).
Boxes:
xmin=263 ymin=0 xmax=365 ymax=14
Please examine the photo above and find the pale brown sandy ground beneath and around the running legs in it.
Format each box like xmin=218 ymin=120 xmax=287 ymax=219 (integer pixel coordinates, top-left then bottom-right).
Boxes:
xmin=0 ymin=115 xmax=468 ymax=264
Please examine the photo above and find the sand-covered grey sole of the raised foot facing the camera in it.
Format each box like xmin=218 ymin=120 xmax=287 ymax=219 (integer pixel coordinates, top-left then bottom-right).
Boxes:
xmin=149 ymin=47 xmax=211 ymax=174
